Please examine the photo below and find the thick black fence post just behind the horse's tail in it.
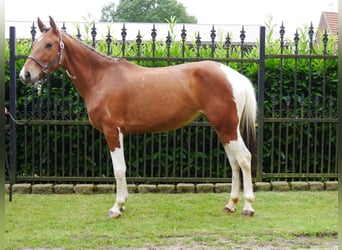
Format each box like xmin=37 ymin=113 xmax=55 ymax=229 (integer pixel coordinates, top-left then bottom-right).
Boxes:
xmin=256 ymin=26 xmax=266 ymax=182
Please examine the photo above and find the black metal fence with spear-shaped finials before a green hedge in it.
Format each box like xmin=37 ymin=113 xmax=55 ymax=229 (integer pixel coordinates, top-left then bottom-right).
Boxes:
xmin=7 ymin=21 xmax=337 ymax=183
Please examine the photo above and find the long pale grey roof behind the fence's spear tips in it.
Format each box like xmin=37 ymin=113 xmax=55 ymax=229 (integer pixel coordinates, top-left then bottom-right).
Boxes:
xmin=5 ymin=21 xmax=260 ymax=44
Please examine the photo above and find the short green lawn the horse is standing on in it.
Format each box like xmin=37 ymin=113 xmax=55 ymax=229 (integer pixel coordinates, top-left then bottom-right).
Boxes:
xmin=5 ymin=192 xmax=338 ymax=249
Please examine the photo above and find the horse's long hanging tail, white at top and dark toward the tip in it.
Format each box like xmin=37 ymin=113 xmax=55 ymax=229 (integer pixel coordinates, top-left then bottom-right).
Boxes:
xmin=240 ymin=82 xmax=257 ymax=176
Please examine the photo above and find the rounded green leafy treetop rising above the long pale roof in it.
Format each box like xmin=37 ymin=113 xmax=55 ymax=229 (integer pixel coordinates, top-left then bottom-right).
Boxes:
xmin=101 ymin=0 xmax=197 ymax=23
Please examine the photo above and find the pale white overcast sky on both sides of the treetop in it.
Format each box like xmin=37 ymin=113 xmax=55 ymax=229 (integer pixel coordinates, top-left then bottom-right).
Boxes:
xmin=5 ymin=0 xmax=338 ymax=33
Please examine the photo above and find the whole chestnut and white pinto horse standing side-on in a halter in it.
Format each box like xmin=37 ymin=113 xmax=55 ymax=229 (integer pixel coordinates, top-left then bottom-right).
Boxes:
xmin=19 ymin=17 xmax=257 ymax=218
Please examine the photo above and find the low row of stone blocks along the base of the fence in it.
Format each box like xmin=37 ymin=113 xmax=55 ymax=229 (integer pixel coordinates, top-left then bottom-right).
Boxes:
xmin=5 ymin=181 xmax=338 ymax=194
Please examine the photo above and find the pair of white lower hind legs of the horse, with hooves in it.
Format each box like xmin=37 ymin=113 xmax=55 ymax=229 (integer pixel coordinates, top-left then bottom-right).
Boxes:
xmin=224 ymin=138 xmax=254 ymax=216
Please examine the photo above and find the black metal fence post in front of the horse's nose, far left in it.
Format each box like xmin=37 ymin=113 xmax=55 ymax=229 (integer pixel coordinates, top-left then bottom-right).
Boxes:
xmin=9 ymin=26 xmax=17 ymax=201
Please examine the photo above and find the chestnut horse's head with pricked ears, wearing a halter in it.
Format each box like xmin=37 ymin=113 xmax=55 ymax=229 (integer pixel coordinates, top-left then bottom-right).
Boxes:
xmin=19 ymin=17 xmax=64 ymax=86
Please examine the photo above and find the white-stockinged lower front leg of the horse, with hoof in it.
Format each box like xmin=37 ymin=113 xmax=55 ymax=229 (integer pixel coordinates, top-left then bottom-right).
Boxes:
xmin=107 ymin=130 xmax=128 ymax=218
